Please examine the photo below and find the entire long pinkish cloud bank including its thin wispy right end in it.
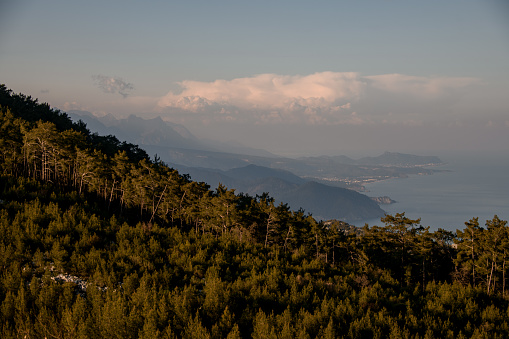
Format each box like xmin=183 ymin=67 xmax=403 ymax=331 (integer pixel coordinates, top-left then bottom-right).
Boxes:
xmin=158 ymin=72 xmax=477 ymax=124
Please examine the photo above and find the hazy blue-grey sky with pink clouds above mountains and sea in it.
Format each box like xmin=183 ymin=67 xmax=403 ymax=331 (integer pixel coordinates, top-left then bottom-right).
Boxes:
xmin=0 ymin=0 xmax=509 ymax=156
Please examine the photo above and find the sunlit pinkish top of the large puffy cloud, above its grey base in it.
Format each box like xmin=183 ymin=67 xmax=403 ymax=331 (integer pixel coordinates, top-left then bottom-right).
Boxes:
xmin=161 ymin=72 xmax=363 ymax=109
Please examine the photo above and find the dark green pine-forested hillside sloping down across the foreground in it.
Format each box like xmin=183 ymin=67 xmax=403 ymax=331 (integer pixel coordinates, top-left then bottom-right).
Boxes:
xmin=0 ymin=85 xmax=509 ymax=338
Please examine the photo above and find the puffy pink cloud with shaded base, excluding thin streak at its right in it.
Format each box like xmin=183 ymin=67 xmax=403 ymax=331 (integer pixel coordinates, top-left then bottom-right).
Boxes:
xmin=159 ymin=72 xmax=365 ymax=124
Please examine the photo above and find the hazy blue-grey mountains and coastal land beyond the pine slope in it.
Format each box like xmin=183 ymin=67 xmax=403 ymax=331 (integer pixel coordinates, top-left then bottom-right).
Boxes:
xmin=67 ymin=111 xmax=442 ymax=223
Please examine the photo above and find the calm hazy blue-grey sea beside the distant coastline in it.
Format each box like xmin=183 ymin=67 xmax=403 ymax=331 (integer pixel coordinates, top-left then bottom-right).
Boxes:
xmin=355 ymin=153 xmax=509 ymax=232
